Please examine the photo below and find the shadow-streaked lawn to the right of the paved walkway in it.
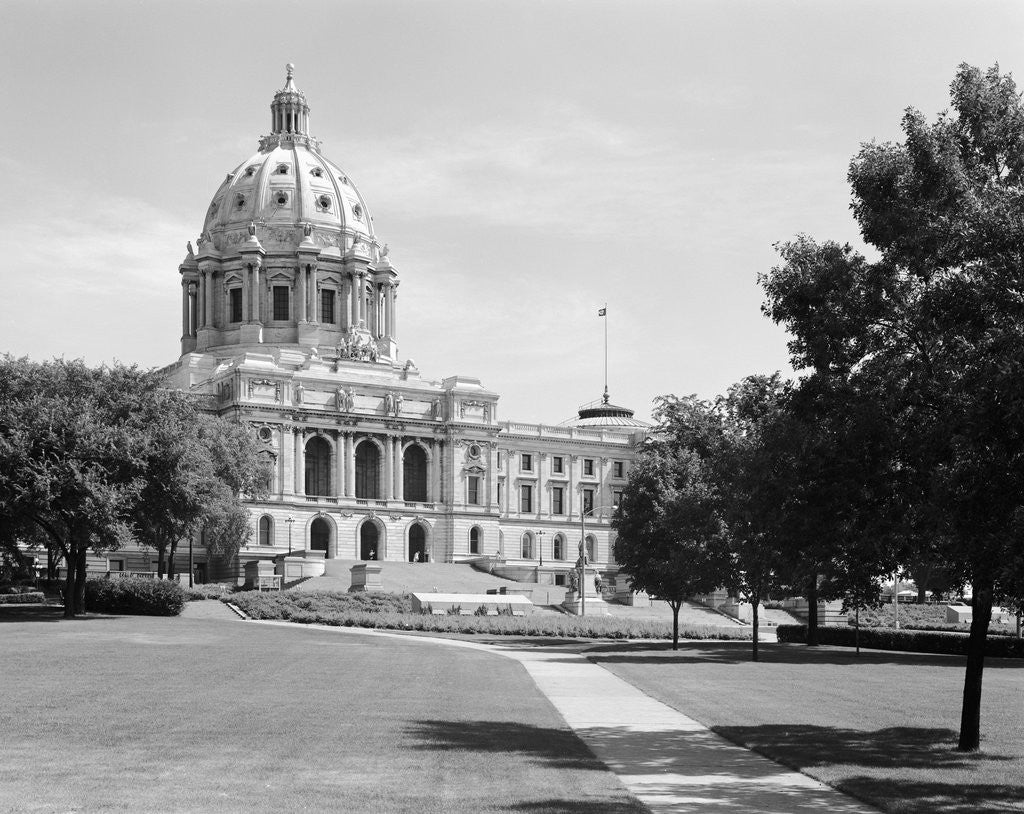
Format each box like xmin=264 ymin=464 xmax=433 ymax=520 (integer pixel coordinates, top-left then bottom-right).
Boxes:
xmin=588 ymin=642 xmax=1024 ymax=814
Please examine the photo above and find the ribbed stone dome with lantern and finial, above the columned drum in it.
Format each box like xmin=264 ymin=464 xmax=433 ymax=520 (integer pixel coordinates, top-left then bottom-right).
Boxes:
xmin=197 ymin=65 xmax=376 ymax=253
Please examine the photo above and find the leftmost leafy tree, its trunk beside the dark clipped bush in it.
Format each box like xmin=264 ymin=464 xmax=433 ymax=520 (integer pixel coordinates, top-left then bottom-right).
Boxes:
xmin=0 ymin=356 xmax=157 ymax=618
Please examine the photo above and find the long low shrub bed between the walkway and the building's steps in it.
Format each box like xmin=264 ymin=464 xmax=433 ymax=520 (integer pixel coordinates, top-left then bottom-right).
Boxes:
xmin=224 ymin=591 xmax=751 ymax=639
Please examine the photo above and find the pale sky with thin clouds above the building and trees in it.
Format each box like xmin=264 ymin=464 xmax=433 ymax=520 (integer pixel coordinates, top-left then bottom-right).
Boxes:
xmin=0 ymin=0 xmax=1024 ymax=423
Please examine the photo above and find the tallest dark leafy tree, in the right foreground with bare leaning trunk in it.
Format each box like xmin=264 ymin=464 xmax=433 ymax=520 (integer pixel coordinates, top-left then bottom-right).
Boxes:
xmin=762 ymin=65 xmax=1024 ymax=751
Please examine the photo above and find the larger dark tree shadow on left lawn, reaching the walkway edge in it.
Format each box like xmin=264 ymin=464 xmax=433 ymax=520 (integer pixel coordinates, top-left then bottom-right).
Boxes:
xmin=406 ymin=721 xmax=605 ymax=771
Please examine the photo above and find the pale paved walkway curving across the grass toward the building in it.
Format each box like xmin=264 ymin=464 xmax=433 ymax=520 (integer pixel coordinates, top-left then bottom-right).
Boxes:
xmin=256 ymin=622 xmax=878 ymax=814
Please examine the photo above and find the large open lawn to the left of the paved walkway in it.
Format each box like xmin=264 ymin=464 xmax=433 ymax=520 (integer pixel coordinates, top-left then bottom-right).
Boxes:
xmin=0 ymin=603 xmax=645 ymax=814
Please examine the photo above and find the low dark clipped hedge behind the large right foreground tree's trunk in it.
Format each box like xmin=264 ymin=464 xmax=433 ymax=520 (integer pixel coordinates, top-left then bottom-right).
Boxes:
xmin=775 ymin=625 xmax=1024 ymax=658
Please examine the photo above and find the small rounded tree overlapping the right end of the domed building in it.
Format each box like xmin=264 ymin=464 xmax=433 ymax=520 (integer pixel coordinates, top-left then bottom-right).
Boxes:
xmin=612 ymin=397 xmax=729 ymax=650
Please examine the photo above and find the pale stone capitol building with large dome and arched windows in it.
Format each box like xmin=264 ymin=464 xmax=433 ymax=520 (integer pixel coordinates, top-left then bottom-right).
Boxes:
xmin=153 ymin=66 xmax=648 ymax=585
